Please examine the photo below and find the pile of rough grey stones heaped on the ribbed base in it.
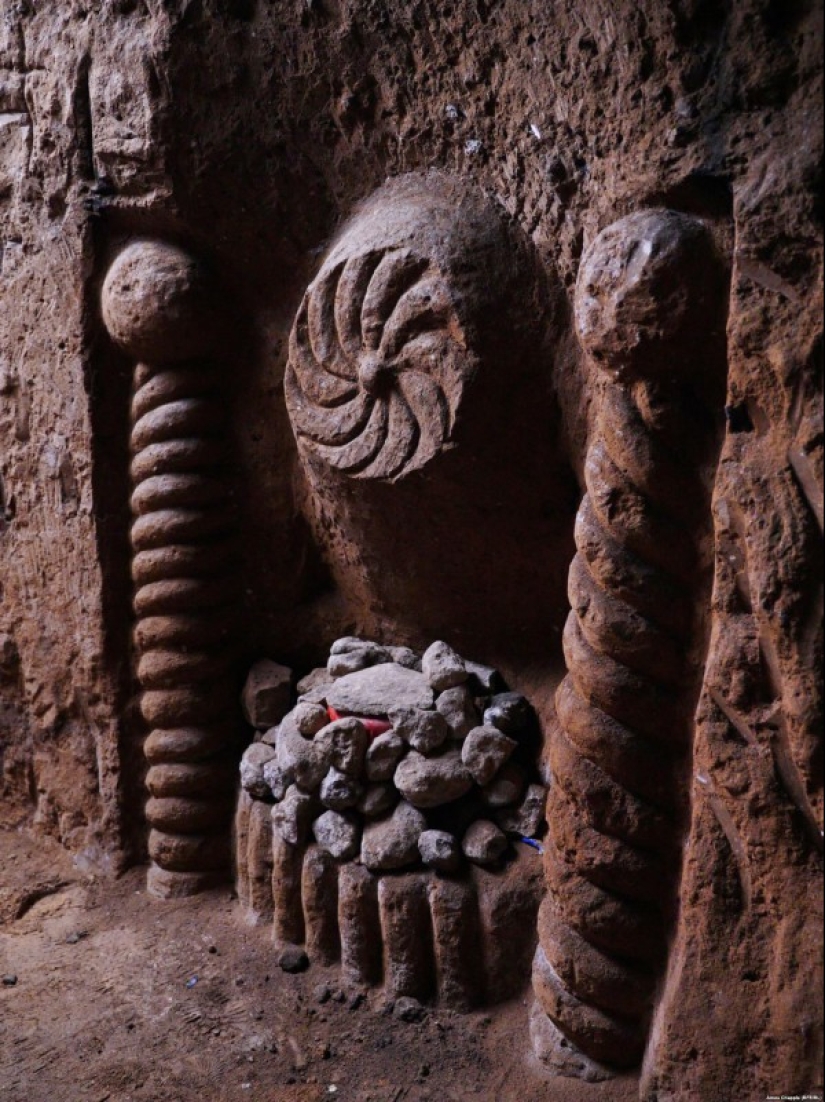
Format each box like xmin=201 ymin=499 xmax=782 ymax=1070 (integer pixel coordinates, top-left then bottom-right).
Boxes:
xmin=240 ymin=638 xmax=545 ymax=873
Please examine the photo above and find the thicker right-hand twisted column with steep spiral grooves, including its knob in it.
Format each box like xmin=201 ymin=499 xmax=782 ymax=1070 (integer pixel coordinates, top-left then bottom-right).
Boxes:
xmin=533 ymin=212 xmax=719 ymax=1078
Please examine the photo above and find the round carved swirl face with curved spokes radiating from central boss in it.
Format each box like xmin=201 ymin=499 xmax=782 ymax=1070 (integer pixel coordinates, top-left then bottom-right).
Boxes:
xmin=285 ymin=248 xmax=471 ymax=482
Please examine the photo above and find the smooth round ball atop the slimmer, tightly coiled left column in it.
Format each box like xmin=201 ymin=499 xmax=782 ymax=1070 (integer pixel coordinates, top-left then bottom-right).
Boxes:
xmin=101 ymin=240 xmax=221 ymax=364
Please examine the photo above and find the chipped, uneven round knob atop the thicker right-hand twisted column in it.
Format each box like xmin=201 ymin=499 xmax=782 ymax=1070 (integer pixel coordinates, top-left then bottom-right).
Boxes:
xmin=574 ymin=210 xmax=719 ymax=382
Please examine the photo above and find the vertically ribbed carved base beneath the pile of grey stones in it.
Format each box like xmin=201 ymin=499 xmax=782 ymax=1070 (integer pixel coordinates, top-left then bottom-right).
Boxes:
xmin=236 ymin=824 xmax=542 ymax=1012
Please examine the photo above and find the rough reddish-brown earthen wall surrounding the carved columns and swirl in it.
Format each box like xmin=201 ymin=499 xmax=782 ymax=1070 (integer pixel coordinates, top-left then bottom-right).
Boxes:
xmin=0 ymin=0 xmax=823 ymax=1100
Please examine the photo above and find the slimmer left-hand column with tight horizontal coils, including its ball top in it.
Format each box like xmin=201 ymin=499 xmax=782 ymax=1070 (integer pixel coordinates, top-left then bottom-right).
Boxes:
xmin=102 ymin=241 xmax=237 ymax=897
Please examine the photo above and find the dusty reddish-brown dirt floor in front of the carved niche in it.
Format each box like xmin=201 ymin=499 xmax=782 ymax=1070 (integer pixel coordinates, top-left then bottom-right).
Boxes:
xmin=0 ymin=831 xmax=637 ymax=1102
